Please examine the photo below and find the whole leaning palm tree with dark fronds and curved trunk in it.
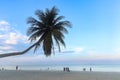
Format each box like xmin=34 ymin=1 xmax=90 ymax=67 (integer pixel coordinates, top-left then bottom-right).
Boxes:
xmin=0 ymin=7 xmax=71 ymax=57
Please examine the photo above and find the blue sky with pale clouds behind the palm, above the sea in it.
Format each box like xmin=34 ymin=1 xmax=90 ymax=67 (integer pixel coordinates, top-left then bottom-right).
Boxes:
xmin=0 ymin=0 xmax=120 ymax=65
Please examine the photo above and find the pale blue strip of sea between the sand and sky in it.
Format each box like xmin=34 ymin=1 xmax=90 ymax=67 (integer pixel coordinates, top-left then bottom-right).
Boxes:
xmin=1 ymin=65 xmax=120 ymax=72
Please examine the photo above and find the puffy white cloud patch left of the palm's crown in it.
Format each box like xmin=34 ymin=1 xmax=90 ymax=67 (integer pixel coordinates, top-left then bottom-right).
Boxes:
xmin=0 ymin=21 xmax=28 ymax=52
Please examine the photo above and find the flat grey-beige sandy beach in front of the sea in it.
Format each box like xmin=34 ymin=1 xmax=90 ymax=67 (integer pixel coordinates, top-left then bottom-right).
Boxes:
xmin=0 ymin=71 xmax=120 ymax=80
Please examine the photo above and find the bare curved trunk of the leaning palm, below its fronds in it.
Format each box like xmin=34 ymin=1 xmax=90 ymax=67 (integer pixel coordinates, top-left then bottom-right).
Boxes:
xmin=0 ymin=42 xmax=37 ymax=58
